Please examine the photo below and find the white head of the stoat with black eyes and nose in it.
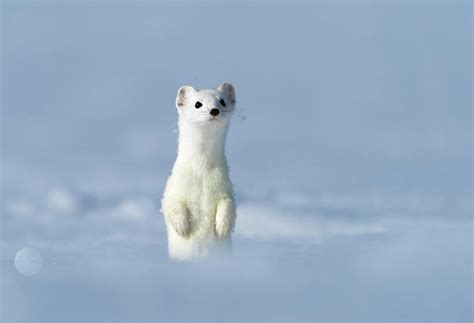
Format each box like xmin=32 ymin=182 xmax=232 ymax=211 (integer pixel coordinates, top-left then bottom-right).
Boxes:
xmin=176 ymin=83 xmax=236 ymax=127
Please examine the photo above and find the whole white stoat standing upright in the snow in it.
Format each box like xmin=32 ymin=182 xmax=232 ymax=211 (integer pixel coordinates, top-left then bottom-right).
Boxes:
xmin=161 ymin=83 xmax=236 ymax=260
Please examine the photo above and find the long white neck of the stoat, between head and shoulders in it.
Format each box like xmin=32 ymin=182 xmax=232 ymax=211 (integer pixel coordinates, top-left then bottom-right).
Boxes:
xmin=177 ymin=118 xmax=228 ymax=167
